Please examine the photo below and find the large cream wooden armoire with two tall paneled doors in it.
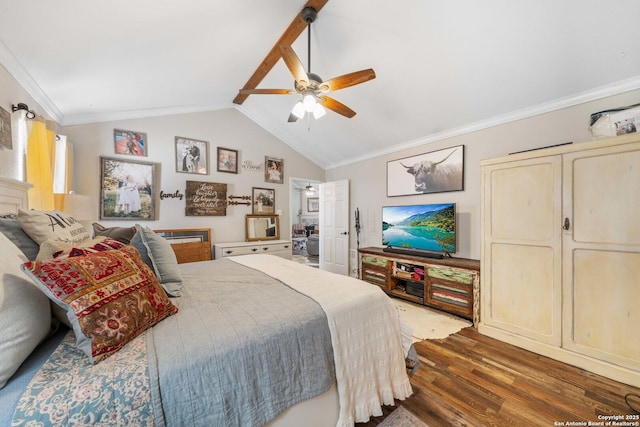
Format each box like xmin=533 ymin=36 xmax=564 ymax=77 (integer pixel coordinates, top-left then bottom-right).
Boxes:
xmin=478 ymin=133 xmax=640 ymax=387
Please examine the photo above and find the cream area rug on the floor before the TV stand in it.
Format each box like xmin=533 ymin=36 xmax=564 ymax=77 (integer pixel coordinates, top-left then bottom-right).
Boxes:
xmin=393 ymin=298 xmax=471 ymax=342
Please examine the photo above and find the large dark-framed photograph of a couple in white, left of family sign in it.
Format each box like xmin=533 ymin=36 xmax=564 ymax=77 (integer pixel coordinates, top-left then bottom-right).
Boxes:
xmin=100 ymin=157 xmax=159 ymax=221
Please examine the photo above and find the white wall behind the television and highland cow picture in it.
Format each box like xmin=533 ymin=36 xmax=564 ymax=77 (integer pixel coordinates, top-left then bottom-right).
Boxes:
xmin=326 ymin=90 xmax=640 ymax=259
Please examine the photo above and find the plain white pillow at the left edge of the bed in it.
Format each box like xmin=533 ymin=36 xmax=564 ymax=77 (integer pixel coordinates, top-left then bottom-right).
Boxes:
xmin=0 ymin=233 xmax=51 ymax=388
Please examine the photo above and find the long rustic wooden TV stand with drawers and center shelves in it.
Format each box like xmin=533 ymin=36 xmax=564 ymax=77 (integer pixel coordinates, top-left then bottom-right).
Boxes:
xmin=358 ymin=247 xmax=480 ymax=325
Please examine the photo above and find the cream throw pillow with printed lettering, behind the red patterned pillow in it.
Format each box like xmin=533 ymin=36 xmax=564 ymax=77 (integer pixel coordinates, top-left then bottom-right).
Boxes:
xmin=18 ymin=209 xmax=91 ymax=244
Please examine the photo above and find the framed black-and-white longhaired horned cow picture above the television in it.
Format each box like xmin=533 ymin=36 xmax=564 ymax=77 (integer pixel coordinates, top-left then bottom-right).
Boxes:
xmin=387 ymin=145 xmax=464 ymax=197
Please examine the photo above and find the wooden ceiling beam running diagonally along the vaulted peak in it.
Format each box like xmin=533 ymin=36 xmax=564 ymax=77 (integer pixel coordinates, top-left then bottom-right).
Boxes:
xmin=233 ymin=0 xmax=329 ymax=104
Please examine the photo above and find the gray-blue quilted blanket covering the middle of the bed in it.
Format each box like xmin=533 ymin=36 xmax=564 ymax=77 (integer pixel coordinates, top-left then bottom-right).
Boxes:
xmin=147 ymin=259 xmax=335 ymax=427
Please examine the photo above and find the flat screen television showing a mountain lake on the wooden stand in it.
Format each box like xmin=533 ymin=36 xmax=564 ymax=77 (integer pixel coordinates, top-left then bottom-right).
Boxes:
xmin=382 ymin=203 xmax=457 ymax=258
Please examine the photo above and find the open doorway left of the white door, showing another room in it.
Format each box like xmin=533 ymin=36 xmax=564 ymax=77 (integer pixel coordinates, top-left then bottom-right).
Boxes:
xmin=289 ymin=178 xmax=320 ymax=267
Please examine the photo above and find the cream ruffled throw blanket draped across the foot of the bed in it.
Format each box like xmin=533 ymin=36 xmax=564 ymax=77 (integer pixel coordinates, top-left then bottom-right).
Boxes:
xmin=229 ymin=254 xmax=412 ymax=427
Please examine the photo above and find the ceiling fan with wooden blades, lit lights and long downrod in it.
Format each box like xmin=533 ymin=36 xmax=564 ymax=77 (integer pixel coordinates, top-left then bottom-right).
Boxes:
xmin=239 ymin=6 xmax=376 ymax=122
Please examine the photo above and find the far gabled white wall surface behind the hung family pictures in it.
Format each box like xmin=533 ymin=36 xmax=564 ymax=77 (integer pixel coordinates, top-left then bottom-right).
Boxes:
xmin=60 ymin=109 xmax=324 ymax=246
